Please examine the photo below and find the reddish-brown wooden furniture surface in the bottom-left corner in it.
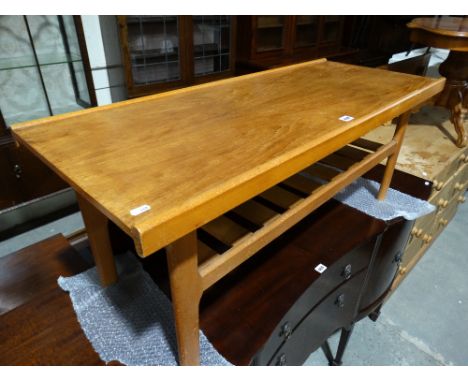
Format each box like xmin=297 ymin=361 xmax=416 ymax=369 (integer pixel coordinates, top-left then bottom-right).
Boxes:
xmin=0 ymin=235 xmax=116 ymax=365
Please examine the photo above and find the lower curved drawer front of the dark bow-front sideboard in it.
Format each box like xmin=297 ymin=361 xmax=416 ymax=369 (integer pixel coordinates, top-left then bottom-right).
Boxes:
xmin=269 ymin=270 xmax=366 ymax=366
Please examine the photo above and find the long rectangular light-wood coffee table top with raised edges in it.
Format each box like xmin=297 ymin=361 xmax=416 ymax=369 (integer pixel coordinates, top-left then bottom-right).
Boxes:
xmin=12 ymin=60 xmax=444 ymax=256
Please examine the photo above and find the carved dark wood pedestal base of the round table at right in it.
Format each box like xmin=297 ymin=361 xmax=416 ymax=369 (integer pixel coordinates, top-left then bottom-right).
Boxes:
xmin=436 ymin=51 xmax=468 ymax=147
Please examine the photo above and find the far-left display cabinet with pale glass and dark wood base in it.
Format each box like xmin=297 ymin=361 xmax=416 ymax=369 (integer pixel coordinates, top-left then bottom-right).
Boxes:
xmin=0 ymin=15 xmax=97 ymax=213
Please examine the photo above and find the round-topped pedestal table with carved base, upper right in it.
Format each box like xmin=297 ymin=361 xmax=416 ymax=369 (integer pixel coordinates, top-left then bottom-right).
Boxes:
xmin=408 ymin=16 xmax=468 ymax=147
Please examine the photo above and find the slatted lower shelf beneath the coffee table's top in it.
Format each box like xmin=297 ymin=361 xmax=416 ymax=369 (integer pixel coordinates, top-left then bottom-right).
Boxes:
xmin=197 ymin=139 xmax=404 ymax=289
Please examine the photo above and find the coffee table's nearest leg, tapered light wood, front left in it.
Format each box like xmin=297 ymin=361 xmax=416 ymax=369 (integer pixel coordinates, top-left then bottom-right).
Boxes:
xmin=166 ymin=231 xmax=203 ymax=365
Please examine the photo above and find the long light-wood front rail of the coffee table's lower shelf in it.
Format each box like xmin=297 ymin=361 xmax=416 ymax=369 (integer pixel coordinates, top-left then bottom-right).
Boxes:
xmin=199 ymin=141 xmax=397 ymax=290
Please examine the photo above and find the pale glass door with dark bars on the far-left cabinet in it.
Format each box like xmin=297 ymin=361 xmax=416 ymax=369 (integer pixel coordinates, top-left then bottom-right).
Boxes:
xmin=0 ymin=15 xmax=94 ymax=126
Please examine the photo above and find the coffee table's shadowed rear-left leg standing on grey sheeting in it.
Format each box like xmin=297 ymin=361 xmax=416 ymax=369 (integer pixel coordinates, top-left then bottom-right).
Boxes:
xmin=77 ymin=193 xmax=117 ymax=286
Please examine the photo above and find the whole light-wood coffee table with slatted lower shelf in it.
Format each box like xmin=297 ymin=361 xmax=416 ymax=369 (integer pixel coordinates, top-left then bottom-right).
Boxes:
xmin=12 ymin=60 xmax=445 ymax=365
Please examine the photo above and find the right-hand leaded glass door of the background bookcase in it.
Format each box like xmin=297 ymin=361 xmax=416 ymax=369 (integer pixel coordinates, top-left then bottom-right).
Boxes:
xmin=192 ymin=16 xmax=231 ymax=77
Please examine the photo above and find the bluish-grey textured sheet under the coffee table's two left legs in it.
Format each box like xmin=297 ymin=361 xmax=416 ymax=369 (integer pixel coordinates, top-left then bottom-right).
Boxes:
xmin=58 ymin=253 xmax=230 ymax=366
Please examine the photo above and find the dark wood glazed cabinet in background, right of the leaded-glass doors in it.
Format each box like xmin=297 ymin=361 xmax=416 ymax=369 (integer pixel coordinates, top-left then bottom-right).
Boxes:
xmin=237 ymin=15 xmax=356 ymax=72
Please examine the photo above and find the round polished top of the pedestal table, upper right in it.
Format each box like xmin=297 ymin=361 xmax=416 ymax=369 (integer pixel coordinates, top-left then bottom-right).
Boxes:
xmin=408 ymin=16 xmax=468 ymax=37
